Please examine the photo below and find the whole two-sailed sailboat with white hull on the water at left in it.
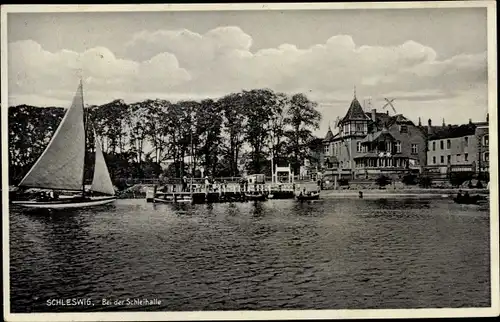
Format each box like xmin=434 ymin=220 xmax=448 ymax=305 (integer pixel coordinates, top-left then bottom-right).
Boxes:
xmin=12 ymin=80 xmax=116 ymax=209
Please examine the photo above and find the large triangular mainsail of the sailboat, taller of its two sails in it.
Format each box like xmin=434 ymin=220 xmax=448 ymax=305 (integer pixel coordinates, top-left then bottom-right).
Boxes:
xmin=19 ymin=82 xmax=85 ymax=190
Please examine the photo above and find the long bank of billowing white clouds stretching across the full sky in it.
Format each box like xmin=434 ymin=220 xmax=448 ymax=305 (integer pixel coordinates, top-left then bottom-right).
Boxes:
xmin=9 ymin=26 xmax=487 ymax=133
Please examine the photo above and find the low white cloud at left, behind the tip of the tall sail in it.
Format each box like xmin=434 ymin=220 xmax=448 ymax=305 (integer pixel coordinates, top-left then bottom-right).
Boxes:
xmin=9 ymin=40 xmax=191 ymax=100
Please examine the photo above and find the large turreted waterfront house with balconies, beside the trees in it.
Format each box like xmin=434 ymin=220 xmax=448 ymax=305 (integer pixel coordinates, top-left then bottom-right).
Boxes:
xmin=323 ymin=93 xmax=427 ymax=178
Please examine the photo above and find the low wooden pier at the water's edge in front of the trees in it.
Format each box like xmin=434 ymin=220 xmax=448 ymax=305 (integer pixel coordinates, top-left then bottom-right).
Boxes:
xmin=146 ymin=183 xmax=317 ymax=204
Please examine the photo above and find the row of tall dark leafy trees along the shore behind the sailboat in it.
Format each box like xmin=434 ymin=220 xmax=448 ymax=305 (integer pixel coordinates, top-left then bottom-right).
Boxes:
xmin=9 ymin=89 xmax=321 ymax=184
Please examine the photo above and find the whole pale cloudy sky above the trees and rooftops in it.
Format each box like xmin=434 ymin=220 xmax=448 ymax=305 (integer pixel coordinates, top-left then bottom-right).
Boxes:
xmin=8 ymin=8 xmax=487 ymax=135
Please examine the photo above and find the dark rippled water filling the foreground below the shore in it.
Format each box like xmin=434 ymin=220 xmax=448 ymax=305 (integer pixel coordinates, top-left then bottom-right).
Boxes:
xmin=10 ymin=199 xmax=490 ymax=313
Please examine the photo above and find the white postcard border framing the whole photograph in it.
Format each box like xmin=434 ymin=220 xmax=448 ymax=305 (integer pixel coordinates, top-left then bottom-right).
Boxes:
xmin=0 ymin=1 xmax=500 ymax=321
